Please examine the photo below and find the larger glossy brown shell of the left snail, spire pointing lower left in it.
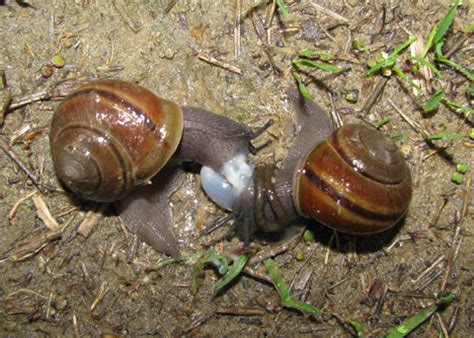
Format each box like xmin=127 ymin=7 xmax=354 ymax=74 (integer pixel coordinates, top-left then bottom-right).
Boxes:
xmin=49 ymin=80 xmax=183 ymax=202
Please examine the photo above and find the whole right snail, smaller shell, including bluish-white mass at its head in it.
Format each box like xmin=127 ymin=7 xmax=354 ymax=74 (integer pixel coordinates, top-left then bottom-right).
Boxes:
xmin=201 ymin=90 xmax=412 ymax=247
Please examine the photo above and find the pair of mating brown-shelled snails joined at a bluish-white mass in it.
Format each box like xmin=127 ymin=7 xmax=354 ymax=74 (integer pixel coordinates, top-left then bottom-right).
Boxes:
xmin=50 ymin=80 xmax=412 ymax=256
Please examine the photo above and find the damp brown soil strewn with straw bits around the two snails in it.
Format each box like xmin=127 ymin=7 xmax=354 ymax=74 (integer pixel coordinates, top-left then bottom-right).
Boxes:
xmin=0 ymin=0 xmax=474 ymax=337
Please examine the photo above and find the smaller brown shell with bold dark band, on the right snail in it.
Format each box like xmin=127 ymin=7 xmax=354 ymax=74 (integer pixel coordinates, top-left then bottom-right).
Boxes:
xmin=294 ymin=125 xmax=412 ymax=234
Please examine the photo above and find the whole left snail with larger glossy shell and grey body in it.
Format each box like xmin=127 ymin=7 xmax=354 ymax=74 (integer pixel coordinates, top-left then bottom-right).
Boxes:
xmin=49 ymin=80 xmax=266 ymax=257
